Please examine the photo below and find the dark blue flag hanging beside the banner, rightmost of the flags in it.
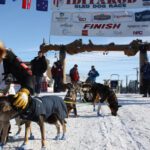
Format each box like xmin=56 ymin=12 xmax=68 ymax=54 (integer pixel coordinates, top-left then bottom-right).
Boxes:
xmin=36 ymin=0 xmax=48 ymax=11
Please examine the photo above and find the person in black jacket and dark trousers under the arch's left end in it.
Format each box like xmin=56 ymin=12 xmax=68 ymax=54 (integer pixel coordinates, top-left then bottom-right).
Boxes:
xmin=31 ymin=51 xmax=47 ymax=96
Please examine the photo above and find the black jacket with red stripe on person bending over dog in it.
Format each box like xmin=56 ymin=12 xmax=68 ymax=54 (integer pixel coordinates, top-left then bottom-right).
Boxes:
xmin=3 ymin=51 xmax=34 ymax=94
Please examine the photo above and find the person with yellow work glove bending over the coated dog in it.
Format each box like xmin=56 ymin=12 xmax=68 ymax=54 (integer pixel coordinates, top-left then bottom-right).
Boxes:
xmin=0 ymin=42 xmax=34 ymax=110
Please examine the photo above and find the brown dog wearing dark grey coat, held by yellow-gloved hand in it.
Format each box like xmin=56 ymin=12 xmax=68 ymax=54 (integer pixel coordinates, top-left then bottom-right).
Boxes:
xmin=0 ymin=95 xmax=67 ymax=148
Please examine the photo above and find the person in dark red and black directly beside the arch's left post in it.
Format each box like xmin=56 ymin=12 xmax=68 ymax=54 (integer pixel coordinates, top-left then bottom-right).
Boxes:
xmin=51 ymin=61 xmax=63 ymax=92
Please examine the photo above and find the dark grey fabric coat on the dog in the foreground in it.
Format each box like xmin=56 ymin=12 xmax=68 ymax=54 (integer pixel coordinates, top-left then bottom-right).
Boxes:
xmin=21 ymin=96 xmax=67 ymax=122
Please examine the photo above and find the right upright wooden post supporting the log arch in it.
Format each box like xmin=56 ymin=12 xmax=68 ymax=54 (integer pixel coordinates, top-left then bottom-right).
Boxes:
xmin=139 ymin=45 xmax=148 ymax=94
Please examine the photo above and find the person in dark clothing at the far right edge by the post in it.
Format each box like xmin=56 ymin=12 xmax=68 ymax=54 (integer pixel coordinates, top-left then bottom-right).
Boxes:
xmin=141 ymin=60 xmax=150 ymax=97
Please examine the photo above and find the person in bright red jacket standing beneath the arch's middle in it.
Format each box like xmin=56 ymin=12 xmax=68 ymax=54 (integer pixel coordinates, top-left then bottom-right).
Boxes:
xmin=70 ymin=64 xmax=80 ymax=86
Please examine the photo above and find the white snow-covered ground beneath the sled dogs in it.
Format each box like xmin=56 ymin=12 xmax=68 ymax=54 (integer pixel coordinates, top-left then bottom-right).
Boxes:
xmin=4 ymin=93 xmax=150 ymax=150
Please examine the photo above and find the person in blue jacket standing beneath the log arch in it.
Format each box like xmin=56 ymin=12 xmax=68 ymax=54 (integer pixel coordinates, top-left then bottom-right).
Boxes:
xmin=86 ymin=66 xmax=99 ymax=83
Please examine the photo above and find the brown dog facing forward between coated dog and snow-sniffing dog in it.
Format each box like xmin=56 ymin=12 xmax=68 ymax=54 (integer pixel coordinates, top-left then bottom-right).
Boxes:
xmin=64 ymin=83 xmax=77 ymax=117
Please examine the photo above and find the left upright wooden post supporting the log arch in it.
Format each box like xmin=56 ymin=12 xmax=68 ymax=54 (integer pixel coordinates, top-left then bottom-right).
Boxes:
xmin=59 ymin=46 xmax=66 ymax=83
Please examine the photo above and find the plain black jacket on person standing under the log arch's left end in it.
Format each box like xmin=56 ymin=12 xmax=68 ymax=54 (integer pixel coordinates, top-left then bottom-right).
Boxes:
xmin=31 ymin=56 xmax=47 ymax=76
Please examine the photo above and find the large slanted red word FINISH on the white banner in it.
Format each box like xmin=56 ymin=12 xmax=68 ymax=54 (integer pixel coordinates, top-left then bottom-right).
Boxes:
xmin=83 ymin=23 xmax=121 ymax=29
